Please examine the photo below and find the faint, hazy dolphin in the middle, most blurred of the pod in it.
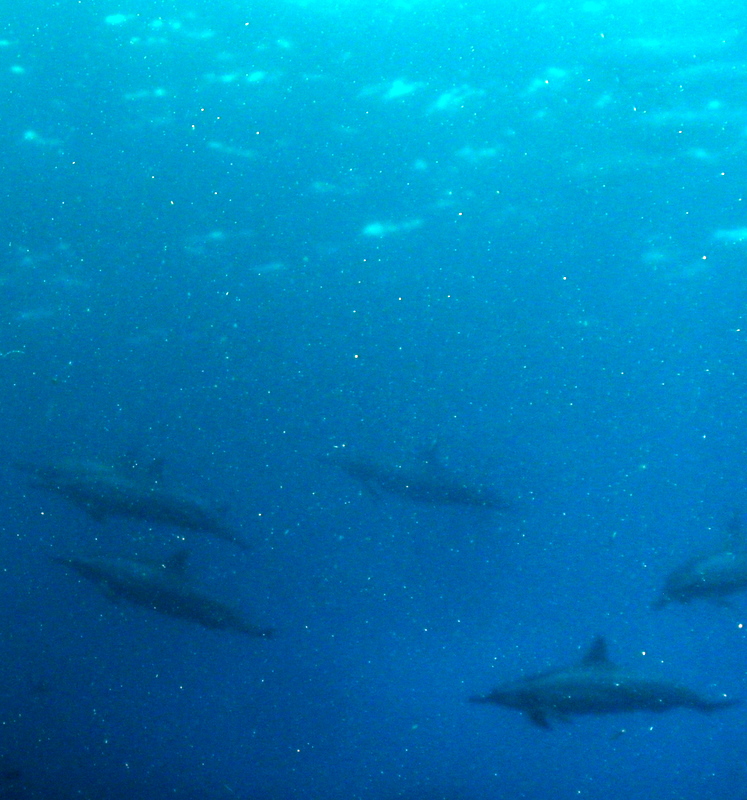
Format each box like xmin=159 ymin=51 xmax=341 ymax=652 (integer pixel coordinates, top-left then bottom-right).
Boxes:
xmin=329 ymin=449 xmax=509 ymax=510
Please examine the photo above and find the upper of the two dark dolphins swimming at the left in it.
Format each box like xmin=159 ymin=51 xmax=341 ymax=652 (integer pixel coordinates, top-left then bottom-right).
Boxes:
xmin=16 ymin=458 xmax=249 ymax=550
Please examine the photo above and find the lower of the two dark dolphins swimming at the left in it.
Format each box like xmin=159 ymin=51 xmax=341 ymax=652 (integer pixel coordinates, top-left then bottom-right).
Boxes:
xmin=53 ymin=550 xmax=273 ymax=637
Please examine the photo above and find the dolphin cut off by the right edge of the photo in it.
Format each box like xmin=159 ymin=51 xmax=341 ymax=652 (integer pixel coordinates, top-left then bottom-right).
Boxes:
xmin=654 ymin=514 xmax=747 ymax=608
